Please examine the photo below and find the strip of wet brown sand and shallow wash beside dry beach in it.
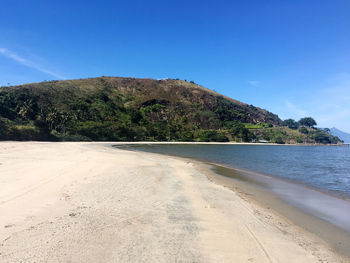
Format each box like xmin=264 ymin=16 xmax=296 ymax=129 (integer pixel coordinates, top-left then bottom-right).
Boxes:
xmin=207 ymin=164 xmax=350 ymax=258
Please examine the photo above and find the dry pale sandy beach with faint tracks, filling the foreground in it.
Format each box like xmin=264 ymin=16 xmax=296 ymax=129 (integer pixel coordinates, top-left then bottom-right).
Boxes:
xmin=0 ymin=142 xmax=350 ymax=263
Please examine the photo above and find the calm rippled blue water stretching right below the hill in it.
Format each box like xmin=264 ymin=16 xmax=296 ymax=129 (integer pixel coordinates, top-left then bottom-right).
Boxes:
xmin=118 ymin=144 xmax=350 ymax=198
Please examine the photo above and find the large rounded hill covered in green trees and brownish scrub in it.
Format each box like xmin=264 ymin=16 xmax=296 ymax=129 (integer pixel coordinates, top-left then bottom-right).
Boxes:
xmin=0 ymin=77 xmax=342 ymax=142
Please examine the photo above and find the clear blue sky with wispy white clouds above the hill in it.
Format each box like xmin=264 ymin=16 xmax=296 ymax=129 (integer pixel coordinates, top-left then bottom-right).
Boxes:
xmin=0 ymin=0 xmax=350 ymax=132
